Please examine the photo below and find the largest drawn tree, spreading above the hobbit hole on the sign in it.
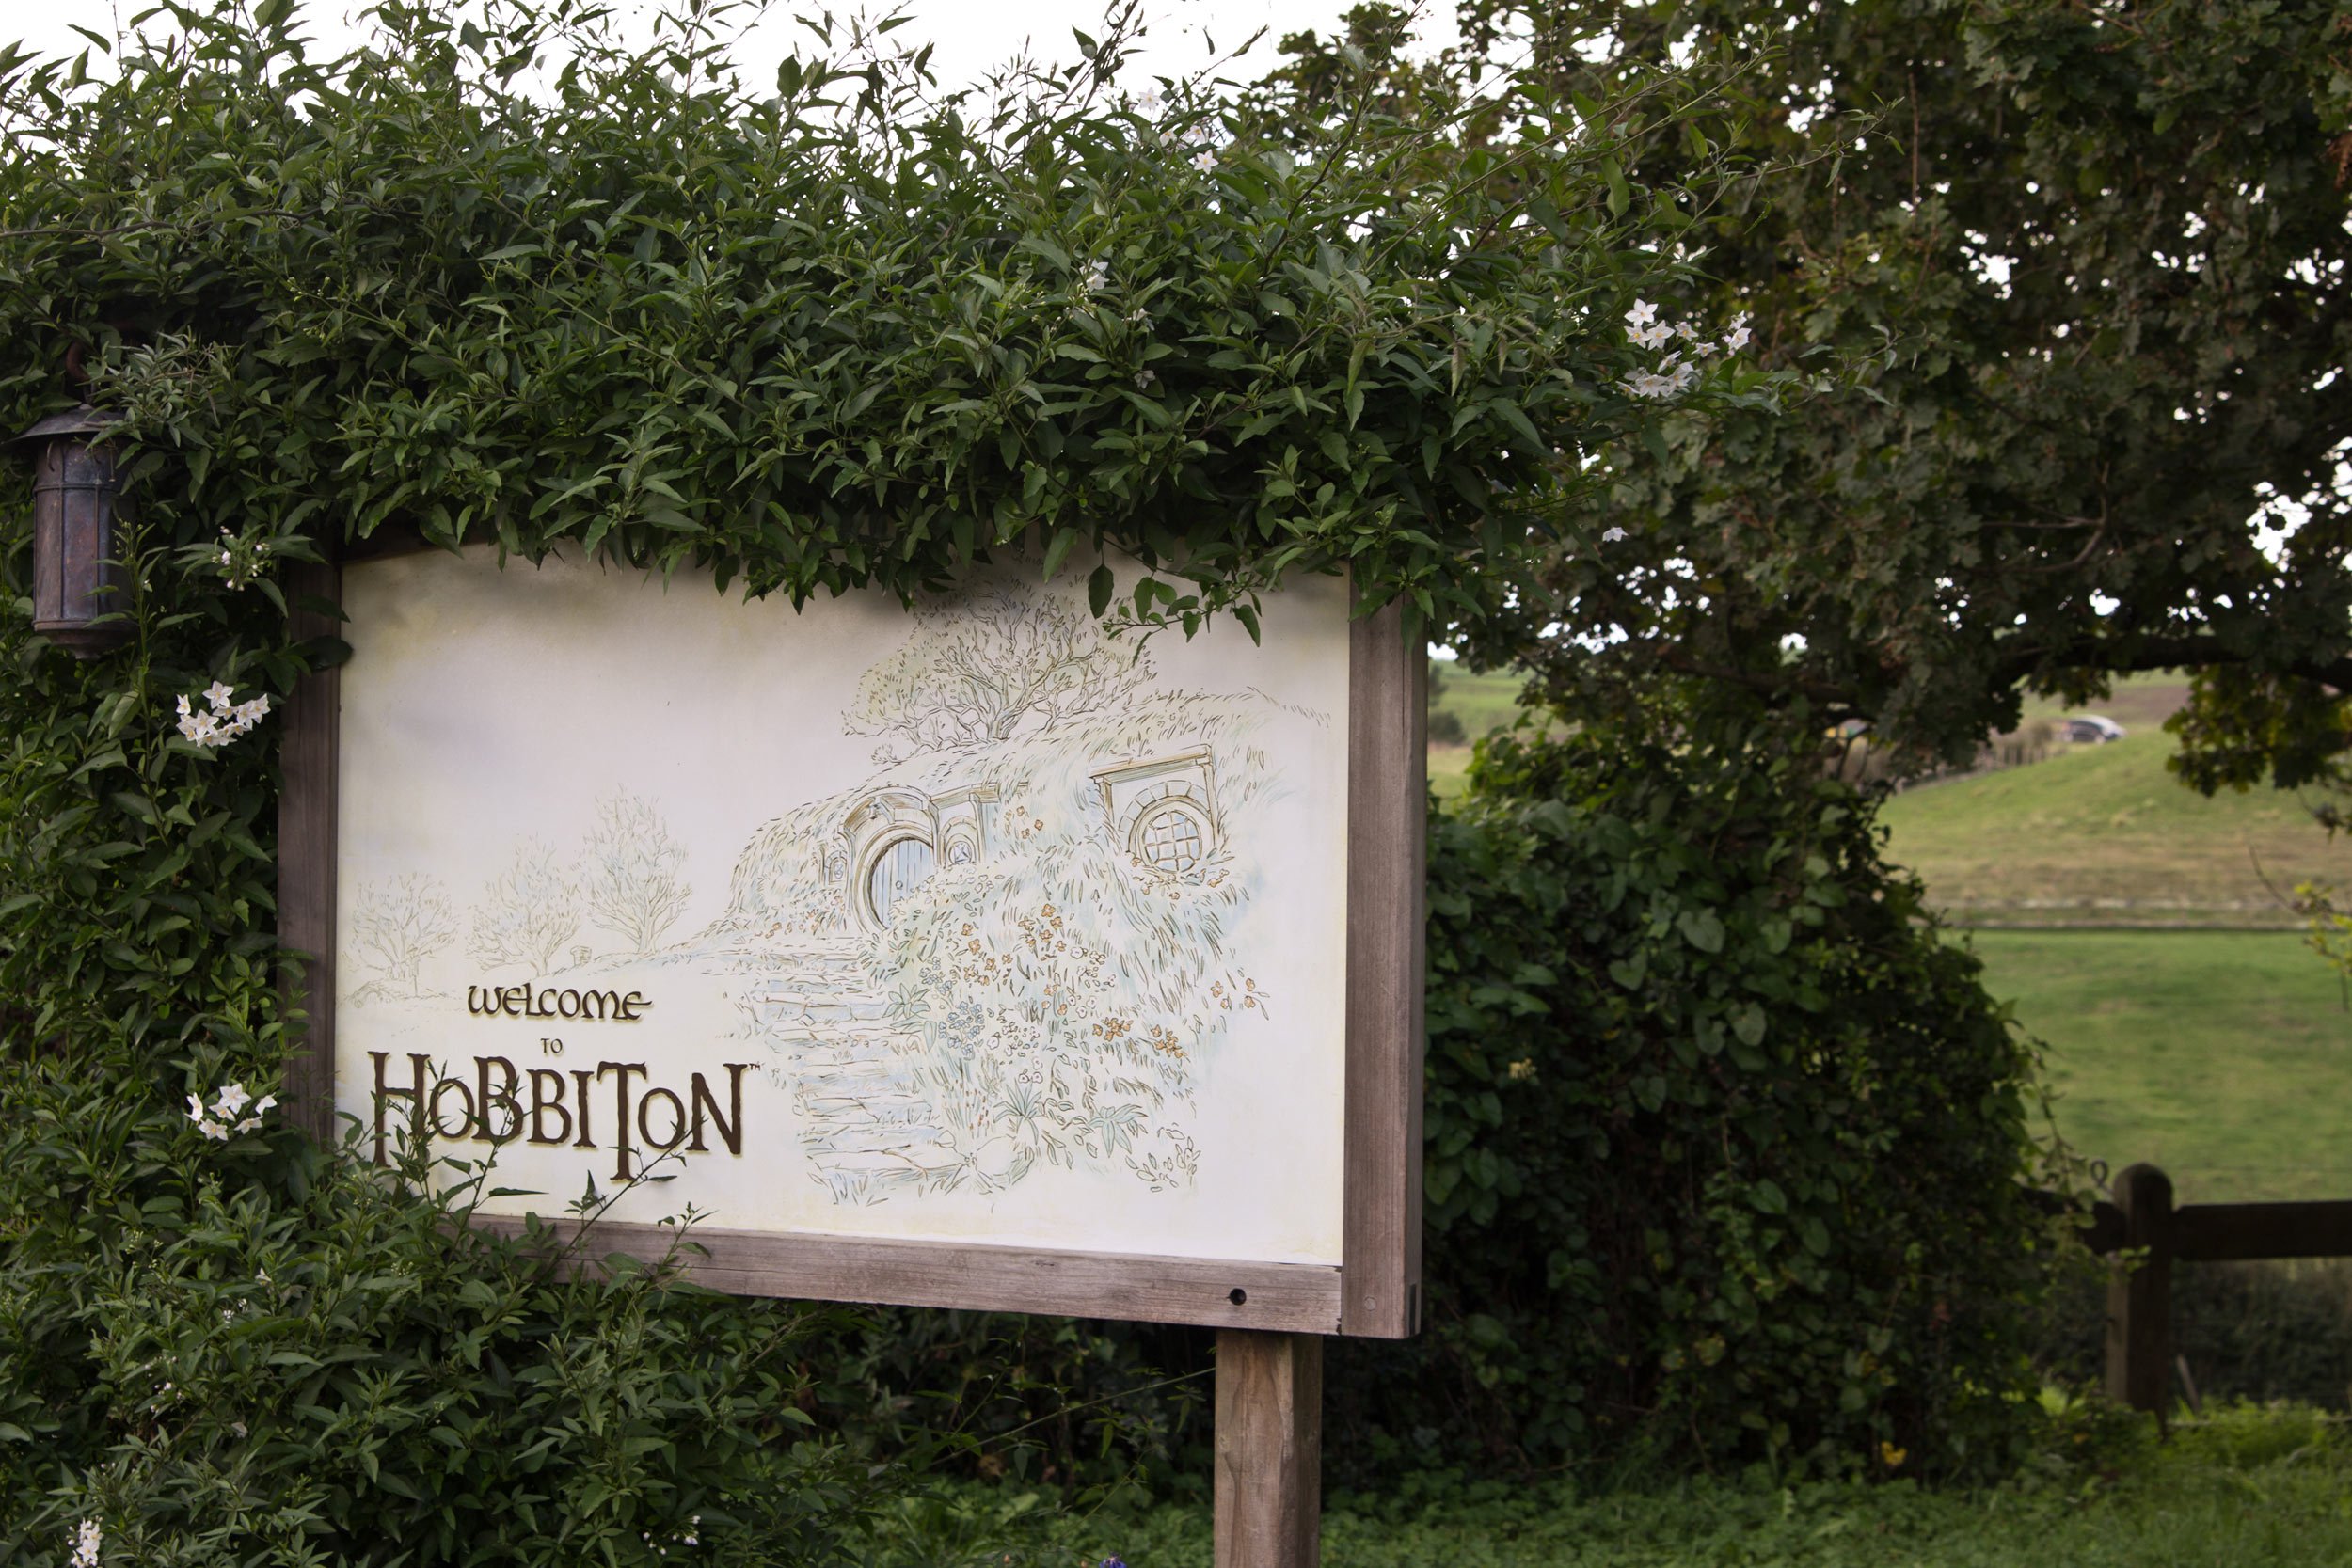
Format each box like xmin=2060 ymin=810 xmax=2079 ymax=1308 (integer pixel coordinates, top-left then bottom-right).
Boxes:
xmin=842 ymin=588 xmax=1151 ymax=750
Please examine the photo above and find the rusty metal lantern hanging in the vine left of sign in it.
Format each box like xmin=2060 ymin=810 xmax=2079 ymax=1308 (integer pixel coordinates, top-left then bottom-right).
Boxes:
xmin=17 ymin=402 xmax=132 ymax=658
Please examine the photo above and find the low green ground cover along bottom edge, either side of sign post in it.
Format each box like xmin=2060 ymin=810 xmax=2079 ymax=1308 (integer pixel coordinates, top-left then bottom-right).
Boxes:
xmin=878 ymin=1406 xmax=2352 ymax=1568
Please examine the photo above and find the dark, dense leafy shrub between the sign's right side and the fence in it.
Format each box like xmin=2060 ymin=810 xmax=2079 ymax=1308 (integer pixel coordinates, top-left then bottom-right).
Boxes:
xmin=1341 ymin=726 xmax=2042 ymax=1474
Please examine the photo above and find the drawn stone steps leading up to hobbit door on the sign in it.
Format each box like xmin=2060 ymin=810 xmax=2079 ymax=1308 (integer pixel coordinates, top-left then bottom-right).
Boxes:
xmin=741 ymin=936 xmax=953 ymax=1204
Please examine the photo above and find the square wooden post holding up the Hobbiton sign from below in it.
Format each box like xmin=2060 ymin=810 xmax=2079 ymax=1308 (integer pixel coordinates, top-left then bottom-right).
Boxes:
xmin=1216 ymin=1328 xmax=1322 ymax=1568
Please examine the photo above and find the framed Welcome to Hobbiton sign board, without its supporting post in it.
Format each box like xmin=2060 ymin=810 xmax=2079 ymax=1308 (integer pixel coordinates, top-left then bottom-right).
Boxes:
xmin=282 ymin=550 xmax=1423 ymax=1336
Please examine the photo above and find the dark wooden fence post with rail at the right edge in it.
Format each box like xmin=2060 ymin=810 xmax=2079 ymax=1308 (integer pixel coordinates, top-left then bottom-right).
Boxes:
xmin=2087 ymin=1166 xmax=2352 ymax=1416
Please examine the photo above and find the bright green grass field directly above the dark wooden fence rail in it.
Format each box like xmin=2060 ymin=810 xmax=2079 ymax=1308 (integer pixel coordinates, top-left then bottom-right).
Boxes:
xmin=1969 ymin=931 xmax=2352 ymax=1204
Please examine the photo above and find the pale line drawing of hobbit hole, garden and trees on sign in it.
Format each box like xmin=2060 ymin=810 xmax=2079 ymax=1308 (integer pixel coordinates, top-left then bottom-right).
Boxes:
xmin=360 ymin=585 xmax=1331 ymax=1206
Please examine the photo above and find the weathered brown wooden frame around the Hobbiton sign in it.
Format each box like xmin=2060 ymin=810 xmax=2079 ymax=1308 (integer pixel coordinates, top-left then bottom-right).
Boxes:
xmin=278 ymin=549 xmax=1428 ymax=1338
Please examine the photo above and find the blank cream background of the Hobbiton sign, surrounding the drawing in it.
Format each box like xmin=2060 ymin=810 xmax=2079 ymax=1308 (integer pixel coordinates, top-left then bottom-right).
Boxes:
xmin=337 ymin=550 xmax=1348 ymax=1265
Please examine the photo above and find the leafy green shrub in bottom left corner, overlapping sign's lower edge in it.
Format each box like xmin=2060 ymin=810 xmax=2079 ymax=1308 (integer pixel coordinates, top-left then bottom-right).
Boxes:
xmin=0 ymin=1053 xmax=903 ymax=1566
